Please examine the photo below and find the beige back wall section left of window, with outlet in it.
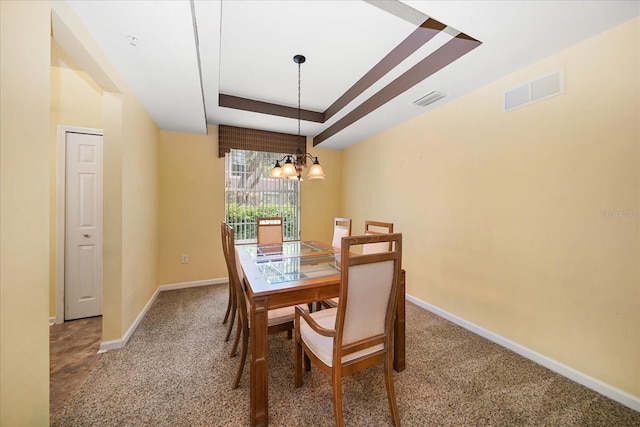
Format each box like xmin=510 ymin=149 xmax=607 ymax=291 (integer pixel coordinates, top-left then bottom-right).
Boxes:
xmin=158 ymin=126 xmax=227 ymax=285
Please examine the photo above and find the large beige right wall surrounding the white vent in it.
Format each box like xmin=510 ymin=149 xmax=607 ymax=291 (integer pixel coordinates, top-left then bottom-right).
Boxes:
xmin=343 ymin=19 xmax=640 ymax=396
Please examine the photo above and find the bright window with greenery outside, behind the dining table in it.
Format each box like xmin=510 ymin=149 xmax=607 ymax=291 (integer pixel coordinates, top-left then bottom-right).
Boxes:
xmin=224 ymin=149 xmax=300 ymax=243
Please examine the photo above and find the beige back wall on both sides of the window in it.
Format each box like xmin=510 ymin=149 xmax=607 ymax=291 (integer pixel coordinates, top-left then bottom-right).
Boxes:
xmin=158 ymin=126 xmax=342 ymax=285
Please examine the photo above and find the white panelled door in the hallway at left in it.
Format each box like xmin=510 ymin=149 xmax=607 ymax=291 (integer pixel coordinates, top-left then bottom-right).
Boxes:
xmin=64 ymin=132 xmax=102 ymax=320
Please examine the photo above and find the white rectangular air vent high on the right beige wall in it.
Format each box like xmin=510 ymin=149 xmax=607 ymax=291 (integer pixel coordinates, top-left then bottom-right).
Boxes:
xmin=502 ymin=69 xmax=564 ymax=111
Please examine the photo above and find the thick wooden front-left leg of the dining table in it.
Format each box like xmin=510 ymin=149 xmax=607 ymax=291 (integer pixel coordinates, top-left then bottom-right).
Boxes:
xmin=249 ymin=298 xmax=269 ymax=427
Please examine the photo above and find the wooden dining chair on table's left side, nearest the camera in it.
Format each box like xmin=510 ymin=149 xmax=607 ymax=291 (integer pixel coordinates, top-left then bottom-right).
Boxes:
xmin=224 ymin=226 xmax=295 ymax=389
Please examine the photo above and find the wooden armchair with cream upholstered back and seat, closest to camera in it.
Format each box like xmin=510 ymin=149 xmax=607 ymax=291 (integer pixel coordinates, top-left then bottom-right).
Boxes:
xmin=294 ymin=233 xmax=402 ymax=427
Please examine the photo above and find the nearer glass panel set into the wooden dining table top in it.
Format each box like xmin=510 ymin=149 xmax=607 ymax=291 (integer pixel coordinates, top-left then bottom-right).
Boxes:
xmin=254 ymin=254 xmax=340 ymax=284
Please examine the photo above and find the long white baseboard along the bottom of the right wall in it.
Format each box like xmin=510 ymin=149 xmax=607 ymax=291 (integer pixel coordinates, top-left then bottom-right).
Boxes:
xmin=407 ymin=295 xmax=640 ymax=412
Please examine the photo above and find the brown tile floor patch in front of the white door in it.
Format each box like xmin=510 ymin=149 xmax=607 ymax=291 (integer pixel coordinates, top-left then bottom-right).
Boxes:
xmin=49 ymin=316 xmax=102 ymax=422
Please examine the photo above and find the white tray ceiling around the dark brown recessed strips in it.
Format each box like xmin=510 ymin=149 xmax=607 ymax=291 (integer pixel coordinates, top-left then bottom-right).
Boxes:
xmin=61 ymin=0 xmax=640 ymax=149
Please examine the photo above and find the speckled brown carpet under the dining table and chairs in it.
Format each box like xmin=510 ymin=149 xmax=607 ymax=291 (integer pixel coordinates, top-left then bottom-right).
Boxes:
xmin=52 ymin=285 xmax=640 ymax=427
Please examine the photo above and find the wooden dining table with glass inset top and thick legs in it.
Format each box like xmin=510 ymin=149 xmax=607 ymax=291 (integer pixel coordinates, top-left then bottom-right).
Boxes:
xmin=237 ymin=241 xmax=405 ymax=426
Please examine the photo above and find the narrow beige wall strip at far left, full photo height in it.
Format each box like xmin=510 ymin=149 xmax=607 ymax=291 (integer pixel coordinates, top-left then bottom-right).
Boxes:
xmin=0 ymin=1 xmax=50 ymax=426
